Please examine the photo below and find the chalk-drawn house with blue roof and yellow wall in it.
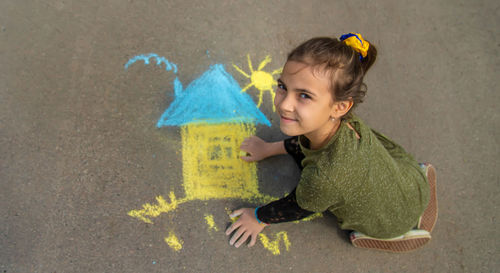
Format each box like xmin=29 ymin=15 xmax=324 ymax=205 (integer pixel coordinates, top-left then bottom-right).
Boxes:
xmin=157 ymin=64 xmax=271 ymax=200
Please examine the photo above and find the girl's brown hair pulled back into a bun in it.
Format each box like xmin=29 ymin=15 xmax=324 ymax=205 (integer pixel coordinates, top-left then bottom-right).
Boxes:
xmin=287 ymin=37 xmax=377 ymax=114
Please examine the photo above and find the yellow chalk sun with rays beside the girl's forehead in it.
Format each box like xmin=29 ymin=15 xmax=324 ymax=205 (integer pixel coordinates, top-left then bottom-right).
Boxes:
xmin=233 ymin=54 xmax=282 ymax=112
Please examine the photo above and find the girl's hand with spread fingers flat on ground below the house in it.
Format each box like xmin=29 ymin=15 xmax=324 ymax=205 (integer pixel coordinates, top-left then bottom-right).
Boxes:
xmin=226 ymin=208 xmax=265 ymax=248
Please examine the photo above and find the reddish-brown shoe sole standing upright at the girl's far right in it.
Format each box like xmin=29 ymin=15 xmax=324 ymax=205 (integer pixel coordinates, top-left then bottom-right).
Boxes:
xmin=417 ymin=163 xmax=438 ymax=232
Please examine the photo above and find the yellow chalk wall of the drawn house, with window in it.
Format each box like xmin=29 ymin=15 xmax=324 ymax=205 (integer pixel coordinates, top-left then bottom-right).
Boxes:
xmin=181 ymin=123 xmax=261 ymax=200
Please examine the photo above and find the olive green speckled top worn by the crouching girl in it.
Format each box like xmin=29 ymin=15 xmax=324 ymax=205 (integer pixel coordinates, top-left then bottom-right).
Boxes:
xmin=296 ymin=115 xmax=429 ymax=238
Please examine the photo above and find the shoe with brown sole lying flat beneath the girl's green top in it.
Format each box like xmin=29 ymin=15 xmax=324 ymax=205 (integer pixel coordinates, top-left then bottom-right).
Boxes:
xmin=350 ymin=229 xmax=431 ymax=252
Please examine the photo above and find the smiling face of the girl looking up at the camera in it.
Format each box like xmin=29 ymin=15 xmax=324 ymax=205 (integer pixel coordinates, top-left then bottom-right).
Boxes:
xmin=274 ymin=61 xmax=335 ymax=141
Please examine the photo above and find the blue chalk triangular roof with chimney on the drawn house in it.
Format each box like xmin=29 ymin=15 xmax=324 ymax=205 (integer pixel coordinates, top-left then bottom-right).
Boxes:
xmin=157 ymin=64 xmax=271 ymax=127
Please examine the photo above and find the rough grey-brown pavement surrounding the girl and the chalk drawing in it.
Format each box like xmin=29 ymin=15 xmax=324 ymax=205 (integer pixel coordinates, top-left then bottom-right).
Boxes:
xmin=0 ymin=0 xmax=500 ymax=273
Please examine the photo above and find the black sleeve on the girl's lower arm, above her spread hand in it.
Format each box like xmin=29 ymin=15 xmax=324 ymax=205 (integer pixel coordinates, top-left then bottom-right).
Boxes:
xmin=256 ymin=189 xmax=314 ymax=224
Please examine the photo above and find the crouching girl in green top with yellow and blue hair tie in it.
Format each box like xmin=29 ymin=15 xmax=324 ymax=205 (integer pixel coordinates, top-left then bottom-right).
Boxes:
xmin=226 ymin=33 xmax=437 ymax=252
